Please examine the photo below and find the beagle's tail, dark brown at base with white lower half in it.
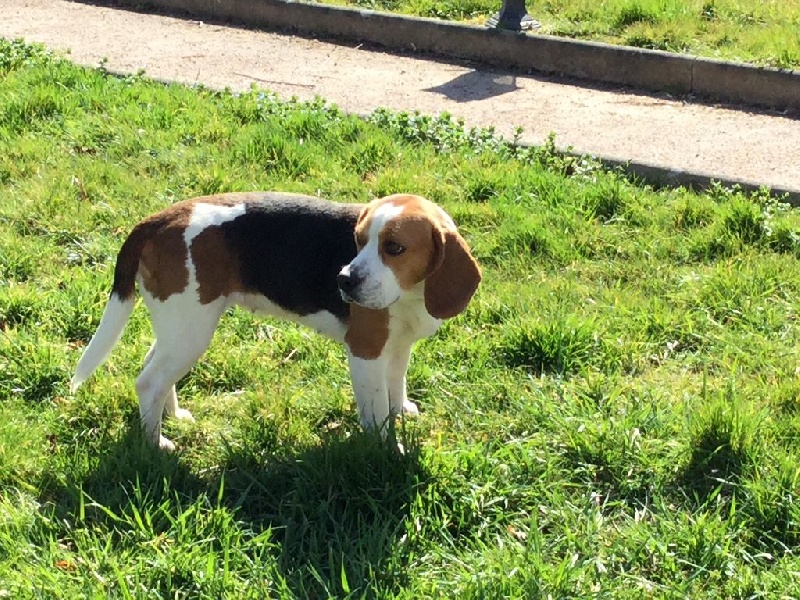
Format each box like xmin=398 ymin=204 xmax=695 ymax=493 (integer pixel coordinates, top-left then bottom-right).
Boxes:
xmin=70 ymin=226 xmax=149 ymax=393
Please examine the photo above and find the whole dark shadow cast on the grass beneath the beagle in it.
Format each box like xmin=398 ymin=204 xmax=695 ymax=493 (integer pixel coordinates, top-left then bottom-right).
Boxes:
xmin=53 ymin=430 xmax=429 ymax=597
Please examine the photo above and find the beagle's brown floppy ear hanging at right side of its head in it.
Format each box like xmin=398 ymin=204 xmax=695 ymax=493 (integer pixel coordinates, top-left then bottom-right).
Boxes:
xmin=425 ymin=226 xmax=481 ymax=319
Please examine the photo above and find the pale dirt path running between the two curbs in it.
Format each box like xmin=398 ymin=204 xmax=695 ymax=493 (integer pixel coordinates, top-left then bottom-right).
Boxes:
xmin=0 ymin=0 xmax=800 ymax=191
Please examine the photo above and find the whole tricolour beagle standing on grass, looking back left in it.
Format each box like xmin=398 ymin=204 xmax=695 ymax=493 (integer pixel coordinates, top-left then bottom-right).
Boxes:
xmin=72 ymin=192 xmax=481 ymax=450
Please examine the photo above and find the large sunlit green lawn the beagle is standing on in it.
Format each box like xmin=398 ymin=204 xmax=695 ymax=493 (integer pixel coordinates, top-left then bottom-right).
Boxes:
xmin=0 ymin=41 xmax=800 ymax=599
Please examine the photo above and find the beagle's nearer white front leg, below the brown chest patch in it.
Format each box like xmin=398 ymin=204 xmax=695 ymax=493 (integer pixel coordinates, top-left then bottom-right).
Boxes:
xmin=347 ymin=351 xmax=389 ymax=437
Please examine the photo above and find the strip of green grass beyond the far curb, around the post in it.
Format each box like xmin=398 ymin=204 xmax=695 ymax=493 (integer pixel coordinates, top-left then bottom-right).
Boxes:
xmin=322 ymin=0 xmax=800 ymax=69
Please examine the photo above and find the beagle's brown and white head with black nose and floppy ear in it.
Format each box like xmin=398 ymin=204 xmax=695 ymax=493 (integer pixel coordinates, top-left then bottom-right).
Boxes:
xmin=337 ymin=194 xmax=481 ymax=319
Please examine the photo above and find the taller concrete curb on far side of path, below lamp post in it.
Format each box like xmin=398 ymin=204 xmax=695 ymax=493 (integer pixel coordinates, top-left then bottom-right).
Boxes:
xmin=108 ymin=0 xmax=800 ymax=111
